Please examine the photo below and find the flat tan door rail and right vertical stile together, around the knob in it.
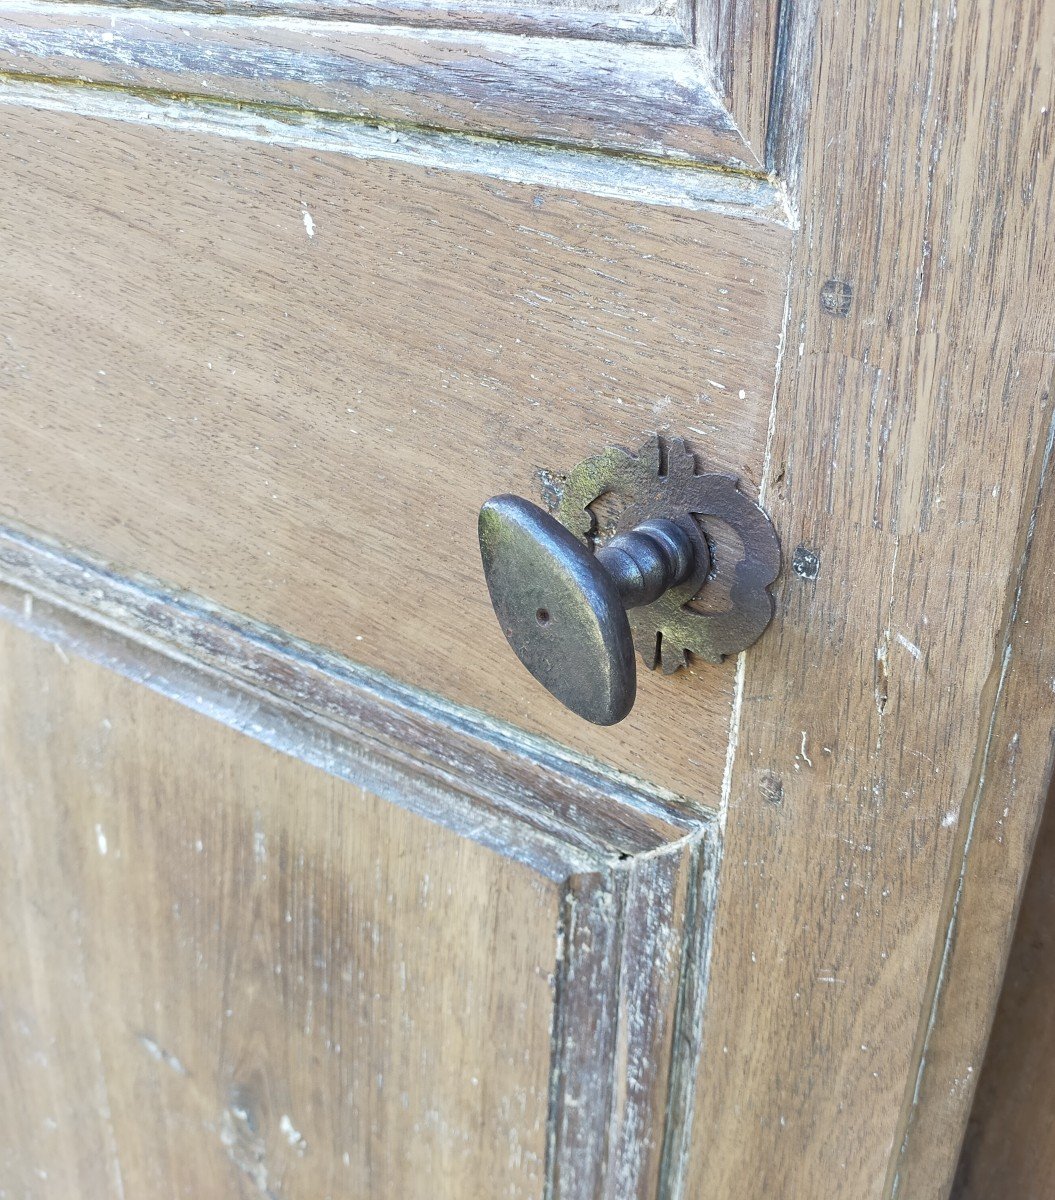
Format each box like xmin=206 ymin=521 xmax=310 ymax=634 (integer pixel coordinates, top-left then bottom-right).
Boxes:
xmin=0 ymin=0 xmax=1055 ymax=1200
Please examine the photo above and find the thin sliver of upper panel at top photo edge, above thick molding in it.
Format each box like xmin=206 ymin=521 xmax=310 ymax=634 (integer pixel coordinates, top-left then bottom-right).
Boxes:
xmin=59 ymin=0 xmax=691 ymax=46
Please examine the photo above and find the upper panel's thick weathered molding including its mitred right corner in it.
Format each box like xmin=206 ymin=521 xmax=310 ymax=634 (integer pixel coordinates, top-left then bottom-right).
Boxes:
xmin=0 ymin=0 xmax=778 ymax=175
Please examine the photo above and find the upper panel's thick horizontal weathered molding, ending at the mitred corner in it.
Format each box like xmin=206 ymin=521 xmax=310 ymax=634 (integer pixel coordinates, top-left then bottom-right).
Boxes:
xmin=0 ymin=0 xmax=761 ymax=172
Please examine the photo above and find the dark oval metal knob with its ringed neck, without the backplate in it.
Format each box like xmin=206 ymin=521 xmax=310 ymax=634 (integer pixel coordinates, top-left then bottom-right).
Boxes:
xmin=479 ymin=496 xmax=696 ymax=725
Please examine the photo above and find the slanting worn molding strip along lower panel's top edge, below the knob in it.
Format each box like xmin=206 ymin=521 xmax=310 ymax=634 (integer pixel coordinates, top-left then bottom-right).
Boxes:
xmin=0 ymin=527 xmax=717 ymax=880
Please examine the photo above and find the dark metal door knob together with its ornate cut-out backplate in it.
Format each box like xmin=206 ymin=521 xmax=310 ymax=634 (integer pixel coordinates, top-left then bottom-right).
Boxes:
xmin=479 ymin=438 xmax=780 ymax=725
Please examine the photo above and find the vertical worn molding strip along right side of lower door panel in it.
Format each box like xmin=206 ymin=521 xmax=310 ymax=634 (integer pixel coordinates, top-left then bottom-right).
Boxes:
xmin=546 ymin=838 xmax=720 ymax=1200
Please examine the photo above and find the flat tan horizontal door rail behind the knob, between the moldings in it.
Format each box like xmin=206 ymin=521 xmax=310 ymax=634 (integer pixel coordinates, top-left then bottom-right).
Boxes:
xmin=0 ymin=100 xmax=789 ymax=805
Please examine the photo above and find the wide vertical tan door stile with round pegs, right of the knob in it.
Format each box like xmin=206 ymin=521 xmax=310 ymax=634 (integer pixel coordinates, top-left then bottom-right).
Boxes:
xmin=687 ymin=0 xmax=1055 ymax=1200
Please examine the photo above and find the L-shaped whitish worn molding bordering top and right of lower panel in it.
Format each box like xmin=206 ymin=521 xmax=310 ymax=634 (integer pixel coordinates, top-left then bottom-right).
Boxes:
xmin=0 ymin=518 xmax=719 ymax=1200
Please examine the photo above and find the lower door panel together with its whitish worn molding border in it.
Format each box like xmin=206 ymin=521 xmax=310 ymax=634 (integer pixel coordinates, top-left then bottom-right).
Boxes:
xmin=0 ymin=576 xmax=714 ymax=1200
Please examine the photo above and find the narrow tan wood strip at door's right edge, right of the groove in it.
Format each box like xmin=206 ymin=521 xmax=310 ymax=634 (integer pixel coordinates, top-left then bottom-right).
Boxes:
xmin=898 ymin=379 xmax=1055 ymax=1200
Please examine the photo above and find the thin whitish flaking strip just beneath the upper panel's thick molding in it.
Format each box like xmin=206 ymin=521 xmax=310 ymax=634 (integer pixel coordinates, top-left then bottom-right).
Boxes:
xmin=0 ymin=72 xmax=787 ymax=217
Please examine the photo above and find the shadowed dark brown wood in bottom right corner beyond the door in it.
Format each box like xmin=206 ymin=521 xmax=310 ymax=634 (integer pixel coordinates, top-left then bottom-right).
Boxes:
xmin=955 ymin=777 xmax=1055 ymax=1200
